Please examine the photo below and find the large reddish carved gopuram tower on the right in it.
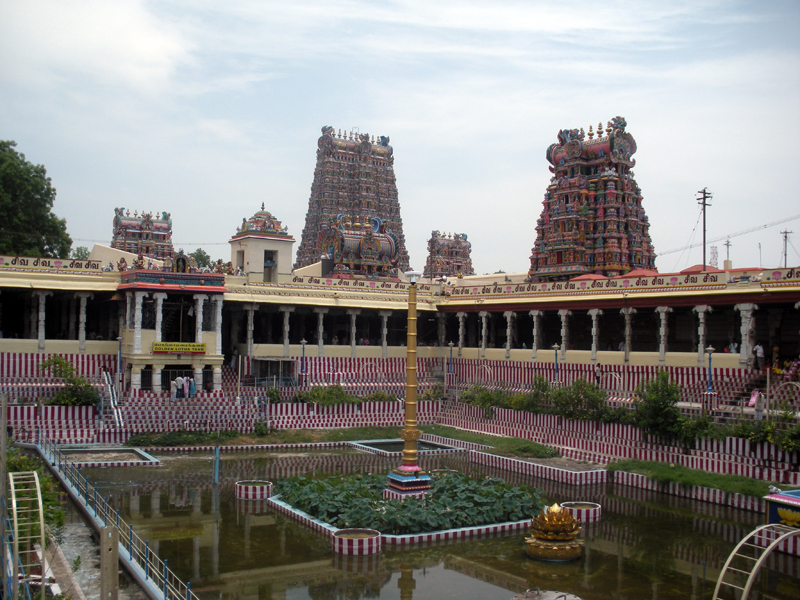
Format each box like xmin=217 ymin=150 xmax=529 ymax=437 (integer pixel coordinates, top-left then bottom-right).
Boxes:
xmin=528 ymin=117 xmax=656 ymax=282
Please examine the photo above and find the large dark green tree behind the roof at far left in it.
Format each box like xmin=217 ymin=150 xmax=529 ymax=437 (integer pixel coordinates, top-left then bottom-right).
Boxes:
xmin=0 ymin=140 xmax=72 ymax=258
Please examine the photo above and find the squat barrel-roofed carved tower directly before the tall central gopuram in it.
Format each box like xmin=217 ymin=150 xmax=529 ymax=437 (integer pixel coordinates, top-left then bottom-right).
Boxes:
xmin=319 ymin=214 xmax=399 ymax=279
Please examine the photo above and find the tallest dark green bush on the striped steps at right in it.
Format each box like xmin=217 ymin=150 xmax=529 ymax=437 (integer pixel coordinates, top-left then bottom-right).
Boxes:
xmin=635 ymin=371 xmax=681 ymax=439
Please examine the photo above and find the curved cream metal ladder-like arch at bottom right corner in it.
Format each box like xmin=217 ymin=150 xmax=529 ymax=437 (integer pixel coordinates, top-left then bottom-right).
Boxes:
xmin=712 ymin=524 xmax=800 ymax=600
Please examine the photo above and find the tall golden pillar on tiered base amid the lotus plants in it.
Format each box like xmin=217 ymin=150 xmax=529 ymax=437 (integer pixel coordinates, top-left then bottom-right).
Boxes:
xmin=387 ymin=271 xmax=431 ymax=497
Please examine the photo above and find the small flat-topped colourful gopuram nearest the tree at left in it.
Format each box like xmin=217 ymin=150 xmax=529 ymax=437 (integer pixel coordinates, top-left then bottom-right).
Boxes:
xmin=111 ymin=208 xmax=175 ymax=260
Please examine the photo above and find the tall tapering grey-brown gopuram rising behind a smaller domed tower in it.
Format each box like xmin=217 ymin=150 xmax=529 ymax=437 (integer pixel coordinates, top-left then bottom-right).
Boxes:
xmin=294 ymin=127 xmax=409 ymax=271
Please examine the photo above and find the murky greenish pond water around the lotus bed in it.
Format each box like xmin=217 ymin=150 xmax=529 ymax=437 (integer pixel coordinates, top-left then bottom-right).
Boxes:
xmin=76 ymin=452 xmax=800 ymax=600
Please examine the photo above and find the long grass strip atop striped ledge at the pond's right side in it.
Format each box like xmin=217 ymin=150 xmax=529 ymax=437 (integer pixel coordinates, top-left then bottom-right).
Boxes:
xmin=606 ymin=460 xmax=782 ymax=498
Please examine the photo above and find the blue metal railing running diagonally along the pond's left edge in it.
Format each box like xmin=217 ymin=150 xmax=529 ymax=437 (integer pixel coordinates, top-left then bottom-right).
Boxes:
xmin=37 ymin=431 xmax=199 ymax=600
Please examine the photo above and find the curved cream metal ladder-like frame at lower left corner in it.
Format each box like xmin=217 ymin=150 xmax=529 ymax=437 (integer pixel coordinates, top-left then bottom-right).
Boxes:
xmin=8 ymin=471 xmax=46 ymax=599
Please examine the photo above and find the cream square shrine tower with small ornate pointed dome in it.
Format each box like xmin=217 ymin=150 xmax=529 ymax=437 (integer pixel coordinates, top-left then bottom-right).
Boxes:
xmin=228 ymin=202 xmax=295 ymax=283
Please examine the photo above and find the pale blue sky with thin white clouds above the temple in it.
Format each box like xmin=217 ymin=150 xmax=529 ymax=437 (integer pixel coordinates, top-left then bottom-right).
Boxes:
xmin=0 ymin=0 xmax=800 ymax=273
